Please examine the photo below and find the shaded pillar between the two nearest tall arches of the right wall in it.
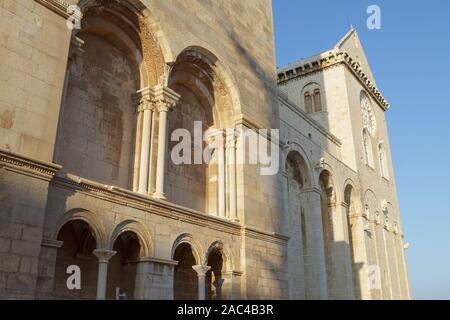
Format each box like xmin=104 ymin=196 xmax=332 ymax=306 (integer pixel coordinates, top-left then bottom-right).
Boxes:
xmin=302 ymin=188 xmax=328 ymax=300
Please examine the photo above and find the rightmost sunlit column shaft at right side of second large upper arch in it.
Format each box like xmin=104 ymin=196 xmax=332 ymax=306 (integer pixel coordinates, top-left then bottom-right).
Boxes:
xmin=226 ymin=129 xmax=239 ymax=222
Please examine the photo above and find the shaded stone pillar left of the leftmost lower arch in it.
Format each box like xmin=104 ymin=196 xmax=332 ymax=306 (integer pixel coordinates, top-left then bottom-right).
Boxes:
xmin=36 ymin=238 xmax=63 ymax=300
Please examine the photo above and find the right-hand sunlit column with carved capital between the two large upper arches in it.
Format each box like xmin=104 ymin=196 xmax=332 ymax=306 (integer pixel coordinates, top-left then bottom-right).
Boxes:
xmin=153 ymin=85 xmax=180 ymax=200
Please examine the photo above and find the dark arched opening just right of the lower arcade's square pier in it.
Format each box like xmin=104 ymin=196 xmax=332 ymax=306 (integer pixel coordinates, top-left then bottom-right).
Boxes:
xmin=173 ymin=243 xmax=198 ymax=300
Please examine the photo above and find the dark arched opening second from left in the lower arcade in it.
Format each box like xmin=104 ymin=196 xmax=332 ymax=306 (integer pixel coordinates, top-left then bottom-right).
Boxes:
xmin=106 ymin=231 xmax=141 ymax=300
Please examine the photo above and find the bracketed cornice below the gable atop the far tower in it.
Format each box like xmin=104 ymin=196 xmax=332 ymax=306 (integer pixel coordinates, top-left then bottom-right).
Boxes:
xmin=278 ymin=51 xmax=389 ymax=111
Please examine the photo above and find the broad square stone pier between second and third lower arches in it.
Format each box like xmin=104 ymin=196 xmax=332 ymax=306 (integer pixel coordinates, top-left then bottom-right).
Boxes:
xmin=134 ymin=257 xmax=178 ymax=300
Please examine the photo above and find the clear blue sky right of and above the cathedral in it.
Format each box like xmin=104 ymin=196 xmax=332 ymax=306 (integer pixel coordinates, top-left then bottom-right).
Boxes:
xmin=273 ymin=0 xmax=450 ymax=299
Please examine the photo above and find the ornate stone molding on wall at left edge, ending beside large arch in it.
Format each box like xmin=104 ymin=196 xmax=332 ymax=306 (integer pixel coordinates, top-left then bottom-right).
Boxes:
xmin=0 ymin=148 xmax=61 ymax=180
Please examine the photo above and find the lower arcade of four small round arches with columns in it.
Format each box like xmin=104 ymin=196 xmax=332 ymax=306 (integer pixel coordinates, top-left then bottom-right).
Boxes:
xmin=51 ymin=212 xmax=234 ymax=300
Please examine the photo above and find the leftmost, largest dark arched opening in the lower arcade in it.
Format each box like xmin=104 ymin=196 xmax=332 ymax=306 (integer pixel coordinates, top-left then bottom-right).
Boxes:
xmin=54 ymin=220 xmax=98 ymax=300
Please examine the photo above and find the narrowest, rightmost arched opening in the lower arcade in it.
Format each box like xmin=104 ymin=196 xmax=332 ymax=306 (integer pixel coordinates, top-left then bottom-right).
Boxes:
xmin=205 ymin=248 xmax=224 ymax=300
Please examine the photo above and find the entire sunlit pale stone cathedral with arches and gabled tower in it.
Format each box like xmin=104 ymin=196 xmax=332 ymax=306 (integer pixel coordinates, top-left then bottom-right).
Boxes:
xmin=0 ymin=0 xmax=410 ymax=299
